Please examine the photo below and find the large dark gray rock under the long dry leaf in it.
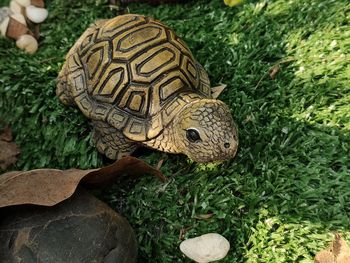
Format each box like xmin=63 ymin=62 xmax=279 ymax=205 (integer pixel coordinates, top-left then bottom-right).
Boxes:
xmin=0 ymin=188 xmax=137 ymax=263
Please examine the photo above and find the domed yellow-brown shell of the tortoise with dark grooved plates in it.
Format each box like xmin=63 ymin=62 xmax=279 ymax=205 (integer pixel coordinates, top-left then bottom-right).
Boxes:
xmin=65 ymin=15 xmax=211 ymax=141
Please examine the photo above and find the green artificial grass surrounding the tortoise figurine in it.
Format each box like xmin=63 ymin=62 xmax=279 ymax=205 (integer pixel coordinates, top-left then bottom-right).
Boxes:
xmin=0 ymin=0 xmax=350 ymax=262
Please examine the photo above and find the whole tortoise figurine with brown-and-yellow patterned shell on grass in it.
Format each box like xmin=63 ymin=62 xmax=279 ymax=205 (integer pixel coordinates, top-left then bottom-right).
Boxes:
xmin=56 ymin=14 xmax=238 ymax=162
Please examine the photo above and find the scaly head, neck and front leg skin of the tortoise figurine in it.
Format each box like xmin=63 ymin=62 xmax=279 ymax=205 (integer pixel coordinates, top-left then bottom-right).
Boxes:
xmin=93 ymin=93 xmax=238 ymax=163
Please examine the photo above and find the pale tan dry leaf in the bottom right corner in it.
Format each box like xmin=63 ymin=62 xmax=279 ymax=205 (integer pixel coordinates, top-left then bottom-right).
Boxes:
xmin=315 ymin=233 xmax=350 ymax=263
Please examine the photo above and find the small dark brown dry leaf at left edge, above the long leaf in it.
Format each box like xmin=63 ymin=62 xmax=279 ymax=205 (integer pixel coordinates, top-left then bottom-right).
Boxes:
xmin=0 ymin=126 xmax=20 ymax=171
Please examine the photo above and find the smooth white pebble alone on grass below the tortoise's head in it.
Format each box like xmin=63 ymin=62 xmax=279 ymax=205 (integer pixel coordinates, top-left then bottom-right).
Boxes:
xmin=180 ymin=233 xmax=230 ymax=263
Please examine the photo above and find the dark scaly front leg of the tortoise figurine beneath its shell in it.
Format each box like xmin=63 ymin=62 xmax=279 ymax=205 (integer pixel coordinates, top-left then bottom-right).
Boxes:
xmin=92 ymin=121 xmax=137 ymax=160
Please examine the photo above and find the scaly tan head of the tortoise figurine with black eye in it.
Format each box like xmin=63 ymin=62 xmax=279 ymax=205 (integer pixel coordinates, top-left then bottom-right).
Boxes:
xmin=173 ymin=99 xmax=238 ymax=163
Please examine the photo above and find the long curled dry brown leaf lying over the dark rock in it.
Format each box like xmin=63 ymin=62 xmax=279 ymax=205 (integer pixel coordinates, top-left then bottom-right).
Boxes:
xmin=0 ymin=156 xmax=166 ymax=210
